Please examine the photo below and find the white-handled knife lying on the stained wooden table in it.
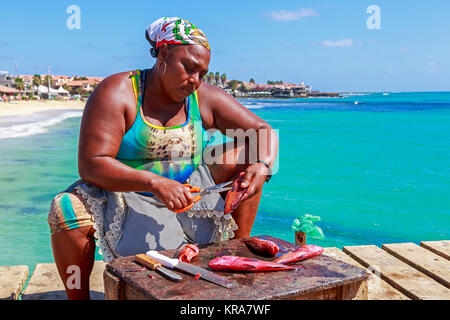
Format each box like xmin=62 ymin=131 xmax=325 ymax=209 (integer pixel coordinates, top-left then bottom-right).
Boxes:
xmin=146 ymin=250 xmax=233 ymax=289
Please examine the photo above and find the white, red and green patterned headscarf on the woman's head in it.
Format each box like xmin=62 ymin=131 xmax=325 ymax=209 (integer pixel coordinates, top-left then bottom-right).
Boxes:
xmin=146 ymin=17 xmax=211 ymax=58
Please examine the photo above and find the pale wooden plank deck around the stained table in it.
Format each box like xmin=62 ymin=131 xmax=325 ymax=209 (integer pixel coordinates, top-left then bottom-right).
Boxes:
xmin=0 ymin=240 xmax=450 ymax=300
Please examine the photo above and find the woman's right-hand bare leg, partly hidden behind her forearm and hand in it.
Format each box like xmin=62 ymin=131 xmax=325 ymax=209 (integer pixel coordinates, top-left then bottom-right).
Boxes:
xmin=208 ymin=142 xmax=262 ymax=238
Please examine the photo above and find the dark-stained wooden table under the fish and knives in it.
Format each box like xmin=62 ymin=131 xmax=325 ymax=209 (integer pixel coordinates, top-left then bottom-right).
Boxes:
xmin=104 ymin=236 xmax=370 ymax=300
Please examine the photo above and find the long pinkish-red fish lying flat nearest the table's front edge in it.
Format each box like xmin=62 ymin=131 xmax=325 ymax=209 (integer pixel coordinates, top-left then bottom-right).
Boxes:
xmin=208 ymin=256 xmax=298 ymax=272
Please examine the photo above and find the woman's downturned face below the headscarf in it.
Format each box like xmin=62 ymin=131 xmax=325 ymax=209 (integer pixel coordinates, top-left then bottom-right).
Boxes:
xmin=158 ymin=45 xmax=211 ymax=101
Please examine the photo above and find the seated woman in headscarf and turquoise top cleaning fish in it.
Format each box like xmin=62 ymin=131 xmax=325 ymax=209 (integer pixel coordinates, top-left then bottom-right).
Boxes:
xmin=48 ymin=18 xmax=278 ymax=299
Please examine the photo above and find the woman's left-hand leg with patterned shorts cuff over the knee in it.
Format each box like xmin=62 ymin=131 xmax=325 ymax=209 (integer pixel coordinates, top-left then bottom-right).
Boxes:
xmin=48 ymin=193 xmax=95 ymax=300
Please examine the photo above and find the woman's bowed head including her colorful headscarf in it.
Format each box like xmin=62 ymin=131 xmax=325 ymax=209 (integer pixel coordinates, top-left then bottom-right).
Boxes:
xmin=146 ymin=18 xmax=211 ymax=101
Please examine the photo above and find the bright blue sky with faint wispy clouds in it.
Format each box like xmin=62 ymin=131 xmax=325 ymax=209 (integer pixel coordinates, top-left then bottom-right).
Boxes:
xmin=0 ymin=0 xmax=450 ymax=91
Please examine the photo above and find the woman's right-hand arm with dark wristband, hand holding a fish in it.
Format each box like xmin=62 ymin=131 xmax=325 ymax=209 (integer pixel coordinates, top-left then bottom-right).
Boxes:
xmin=199 ymin=83 xmax=278 ymax=198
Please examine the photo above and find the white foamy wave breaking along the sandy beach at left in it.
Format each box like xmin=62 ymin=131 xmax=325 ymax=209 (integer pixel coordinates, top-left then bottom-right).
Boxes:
xmin=0 ymin=111 xmax=83 ymax=139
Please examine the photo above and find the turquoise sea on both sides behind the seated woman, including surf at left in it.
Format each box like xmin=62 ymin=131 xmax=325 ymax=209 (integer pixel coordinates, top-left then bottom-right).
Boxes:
xmin=0 ymin=92 xmax=450 ymax=270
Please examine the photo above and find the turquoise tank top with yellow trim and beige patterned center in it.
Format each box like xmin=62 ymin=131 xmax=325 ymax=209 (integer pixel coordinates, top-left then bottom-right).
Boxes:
xmin=116 ymin=70 xmax=207 ymax=183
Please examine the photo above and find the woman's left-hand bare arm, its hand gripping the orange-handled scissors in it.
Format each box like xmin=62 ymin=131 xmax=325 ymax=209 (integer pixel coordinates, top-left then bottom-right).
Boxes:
xmin=78 ymin=73 xmax=192 ymax=210
